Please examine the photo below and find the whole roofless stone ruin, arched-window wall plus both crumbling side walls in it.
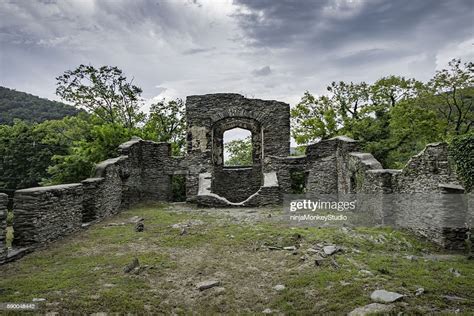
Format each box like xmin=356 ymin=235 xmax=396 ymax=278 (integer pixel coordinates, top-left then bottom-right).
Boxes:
xmin=0 ymin=94 xmax=474 ymax=262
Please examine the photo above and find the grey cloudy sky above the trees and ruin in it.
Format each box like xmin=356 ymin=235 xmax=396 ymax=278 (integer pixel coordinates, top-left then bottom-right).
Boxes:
xmin=0 ymin=0 xmax=474 ymax=110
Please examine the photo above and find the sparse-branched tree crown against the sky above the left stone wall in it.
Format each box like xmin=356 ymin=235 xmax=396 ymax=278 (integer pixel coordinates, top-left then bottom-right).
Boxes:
xmin=56 ymin=65 xmax=144 ymax=128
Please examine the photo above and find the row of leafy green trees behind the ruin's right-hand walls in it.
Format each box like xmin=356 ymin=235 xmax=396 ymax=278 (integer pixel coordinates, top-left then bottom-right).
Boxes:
xmin=291 ymin=59 xmax=474 ymax=168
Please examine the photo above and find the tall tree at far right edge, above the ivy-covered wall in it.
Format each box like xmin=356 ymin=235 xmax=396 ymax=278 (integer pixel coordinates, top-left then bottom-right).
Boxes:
xmin=425 ymin=59 xmax=474 ymax=135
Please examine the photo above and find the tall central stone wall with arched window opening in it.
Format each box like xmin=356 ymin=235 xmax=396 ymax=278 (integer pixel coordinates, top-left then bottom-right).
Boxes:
xmin=186 ymin=94 xmax=290 ymax=206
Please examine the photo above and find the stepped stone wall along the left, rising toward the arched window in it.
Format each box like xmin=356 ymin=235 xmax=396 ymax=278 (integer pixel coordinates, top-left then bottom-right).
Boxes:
xmin=8 ymin=138 xmax=179 ymax=256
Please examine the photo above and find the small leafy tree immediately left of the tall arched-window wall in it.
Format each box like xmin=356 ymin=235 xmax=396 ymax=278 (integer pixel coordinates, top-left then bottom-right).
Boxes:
xmin=143 ymin=99 xmax=186 ymax=155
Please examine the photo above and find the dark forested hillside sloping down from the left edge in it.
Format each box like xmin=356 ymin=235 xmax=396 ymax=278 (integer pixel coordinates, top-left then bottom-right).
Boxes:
xmin=0 ymin=86 xmax=78 ymax=124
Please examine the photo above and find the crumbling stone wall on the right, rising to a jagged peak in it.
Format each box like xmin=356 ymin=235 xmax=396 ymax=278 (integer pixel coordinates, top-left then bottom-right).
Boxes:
xmin=356 ymin=143 xmax=473 ymax=249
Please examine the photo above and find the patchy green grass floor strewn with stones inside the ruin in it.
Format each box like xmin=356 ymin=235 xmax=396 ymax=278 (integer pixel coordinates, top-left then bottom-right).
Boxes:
xmin=0 ymin=204 xmax=474 ymax=315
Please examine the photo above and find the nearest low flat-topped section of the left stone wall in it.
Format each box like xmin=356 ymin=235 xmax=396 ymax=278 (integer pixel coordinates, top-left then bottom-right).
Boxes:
xmin=13 ymin=184 xmax=83 ymax=247
